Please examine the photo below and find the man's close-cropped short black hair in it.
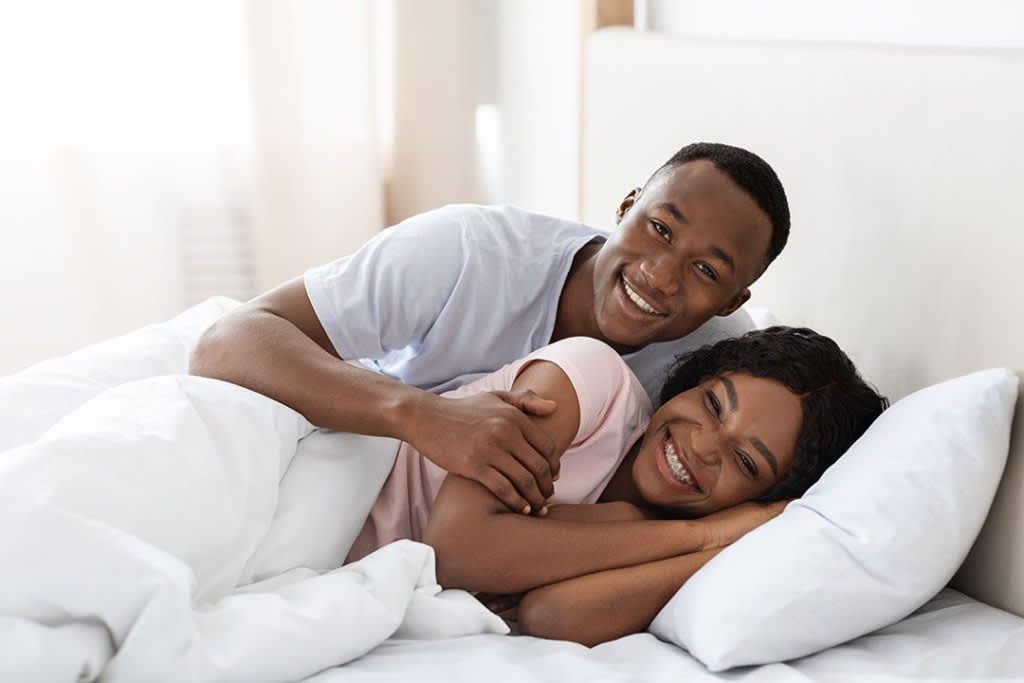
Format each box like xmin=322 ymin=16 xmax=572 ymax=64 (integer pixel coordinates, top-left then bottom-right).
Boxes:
xmin=647 ymin=142 xmax=790 ymax=267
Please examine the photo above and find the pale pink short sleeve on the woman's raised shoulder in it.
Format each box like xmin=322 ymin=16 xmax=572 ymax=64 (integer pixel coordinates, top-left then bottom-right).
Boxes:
xmin=526 ymin=337 xmax=648 ymax=447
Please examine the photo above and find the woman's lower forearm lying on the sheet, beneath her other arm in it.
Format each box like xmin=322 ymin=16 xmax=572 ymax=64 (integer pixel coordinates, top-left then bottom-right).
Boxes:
xmin=518 ymin=548 xmax=722 ymax=646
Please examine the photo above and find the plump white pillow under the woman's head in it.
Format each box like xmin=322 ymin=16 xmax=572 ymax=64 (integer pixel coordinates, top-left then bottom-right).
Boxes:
xmin=650 ymin=369 xmax=1018 ymax=672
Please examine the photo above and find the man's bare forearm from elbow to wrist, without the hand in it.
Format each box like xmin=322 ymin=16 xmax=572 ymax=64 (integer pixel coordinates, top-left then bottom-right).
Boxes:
xmin=189 ymin=309 xmax=437 ymax=440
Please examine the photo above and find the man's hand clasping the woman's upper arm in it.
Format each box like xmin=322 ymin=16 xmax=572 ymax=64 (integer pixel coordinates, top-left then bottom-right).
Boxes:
xmin=404 ymin=391 xmax=561 ymax=514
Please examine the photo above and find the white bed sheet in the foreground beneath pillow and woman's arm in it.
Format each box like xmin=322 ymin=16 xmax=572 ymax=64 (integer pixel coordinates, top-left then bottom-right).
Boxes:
xmin=306 ymin=589 xmax=1024 ymax=683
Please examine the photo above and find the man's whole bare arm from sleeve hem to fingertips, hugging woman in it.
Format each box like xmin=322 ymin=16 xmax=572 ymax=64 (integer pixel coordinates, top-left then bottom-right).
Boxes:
xmin=189 ymin=278 xmax=557 ymax=511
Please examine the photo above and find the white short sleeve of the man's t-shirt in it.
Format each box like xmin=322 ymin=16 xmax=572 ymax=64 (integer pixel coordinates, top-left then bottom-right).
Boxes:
xmin=303 ymin=206 xmax=469 ymax=359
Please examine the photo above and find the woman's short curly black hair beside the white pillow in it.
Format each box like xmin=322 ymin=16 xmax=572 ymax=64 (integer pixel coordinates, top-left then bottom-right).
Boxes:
xmin=660 ymin=327 xmax=889 ymax=502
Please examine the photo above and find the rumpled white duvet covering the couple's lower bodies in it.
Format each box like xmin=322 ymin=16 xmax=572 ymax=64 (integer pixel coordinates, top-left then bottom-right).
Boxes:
xmin=0 ymin=299 xmax=507 ymax=682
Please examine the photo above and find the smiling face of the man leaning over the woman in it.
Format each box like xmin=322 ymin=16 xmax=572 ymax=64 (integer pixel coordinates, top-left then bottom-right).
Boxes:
xmin=594 ymin=160 xmax=771 ymax=349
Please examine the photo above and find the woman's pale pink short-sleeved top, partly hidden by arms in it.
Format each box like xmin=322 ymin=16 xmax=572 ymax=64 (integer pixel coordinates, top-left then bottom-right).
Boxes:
xmin=347 ymin=337 xmax=652 ymax=562
